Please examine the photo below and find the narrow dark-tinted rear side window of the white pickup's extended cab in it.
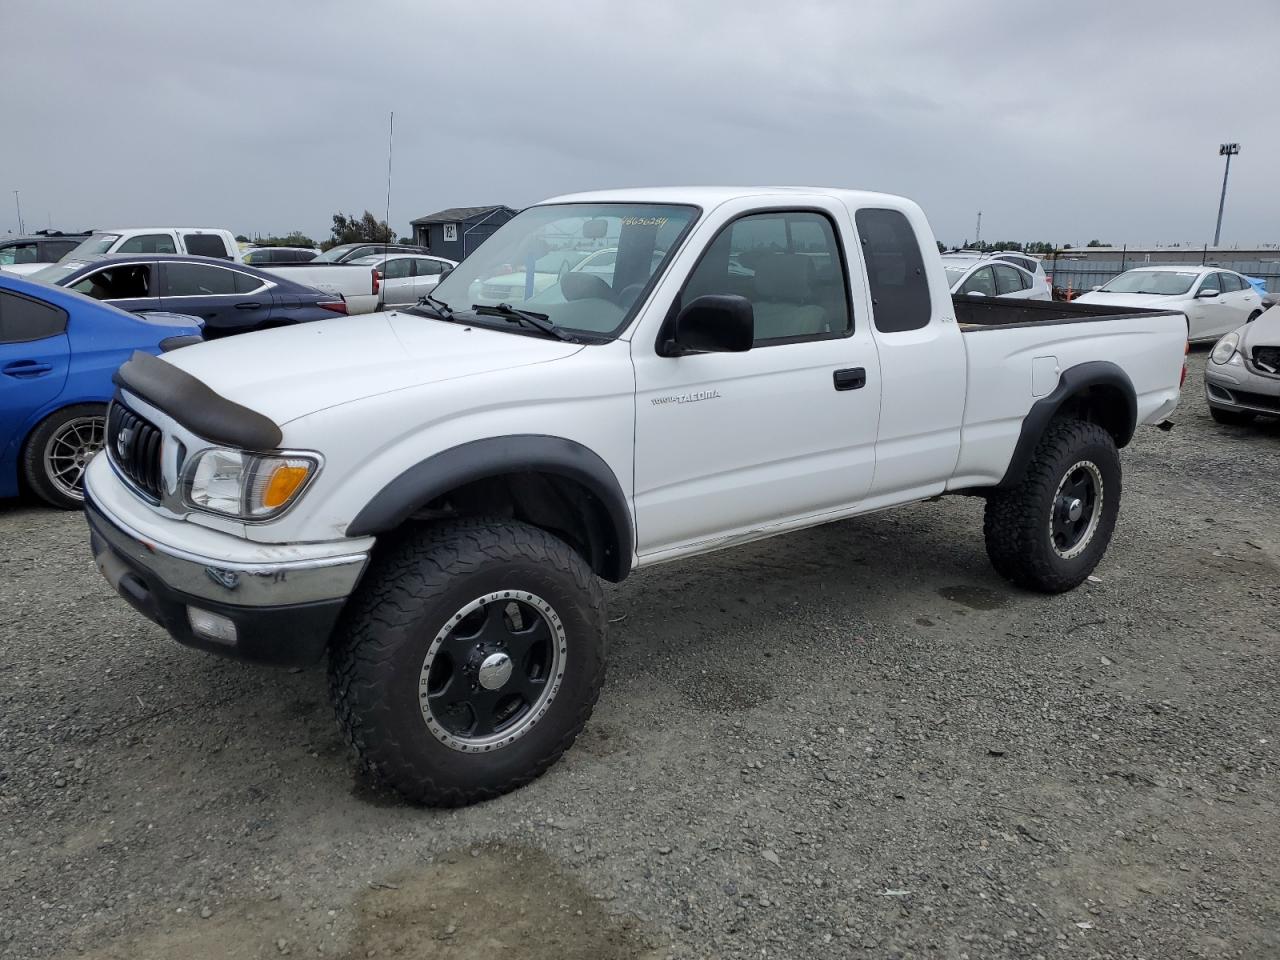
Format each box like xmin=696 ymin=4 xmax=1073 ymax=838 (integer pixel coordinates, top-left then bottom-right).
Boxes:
xmin=854 ymin=207 xmax=933 ymax=333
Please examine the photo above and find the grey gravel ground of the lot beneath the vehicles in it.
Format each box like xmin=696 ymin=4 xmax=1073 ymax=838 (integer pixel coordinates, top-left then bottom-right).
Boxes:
xmin=0 ymin=353 xmax=1280 ymax=960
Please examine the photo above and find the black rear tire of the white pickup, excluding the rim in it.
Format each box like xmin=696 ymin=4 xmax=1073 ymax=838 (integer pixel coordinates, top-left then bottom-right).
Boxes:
xmin=983 ymin=420 xmax=1120 ymax=594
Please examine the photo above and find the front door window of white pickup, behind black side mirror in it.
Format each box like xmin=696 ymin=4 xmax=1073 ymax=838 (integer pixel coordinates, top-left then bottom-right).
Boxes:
xmin=681 ymin=210 xmax=852 ymax=346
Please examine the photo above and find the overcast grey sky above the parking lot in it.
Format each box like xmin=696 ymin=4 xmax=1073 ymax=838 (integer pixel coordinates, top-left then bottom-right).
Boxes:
xmin=0 ymin=0 xmax=1280 ymax=246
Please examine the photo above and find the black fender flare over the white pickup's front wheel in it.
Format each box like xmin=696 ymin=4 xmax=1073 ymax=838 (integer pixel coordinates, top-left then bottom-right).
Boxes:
xmin=347 ymin=434 xmax=635 ymax=580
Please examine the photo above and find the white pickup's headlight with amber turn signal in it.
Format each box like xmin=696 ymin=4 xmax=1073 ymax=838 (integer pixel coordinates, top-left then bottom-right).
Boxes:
xmin=182 ymin=447 xmax=320 ymax=520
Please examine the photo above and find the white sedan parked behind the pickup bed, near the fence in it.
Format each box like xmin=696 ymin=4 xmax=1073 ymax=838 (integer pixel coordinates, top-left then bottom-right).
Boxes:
xmin=1076 ymin=266 xmax=1262 ymax=343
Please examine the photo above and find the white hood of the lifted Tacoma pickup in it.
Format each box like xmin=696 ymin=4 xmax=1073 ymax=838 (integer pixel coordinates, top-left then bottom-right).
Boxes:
xmin=154 ymin=312 xmax=582 ymax=426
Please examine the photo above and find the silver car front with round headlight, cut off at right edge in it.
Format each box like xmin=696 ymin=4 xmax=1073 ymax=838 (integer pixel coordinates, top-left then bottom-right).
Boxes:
xmin=1204 ymin=307 xmax=1280 ymax=424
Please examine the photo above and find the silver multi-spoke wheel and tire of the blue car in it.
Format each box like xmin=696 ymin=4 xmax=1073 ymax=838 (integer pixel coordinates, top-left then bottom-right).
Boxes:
xmin=22 ymin=403 xmax=106 ymax=509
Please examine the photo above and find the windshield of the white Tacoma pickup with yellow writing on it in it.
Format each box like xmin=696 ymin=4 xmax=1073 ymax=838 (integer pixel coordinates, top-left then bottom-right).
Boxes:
xmin=433 ymin=204 xmax=698 ymax=338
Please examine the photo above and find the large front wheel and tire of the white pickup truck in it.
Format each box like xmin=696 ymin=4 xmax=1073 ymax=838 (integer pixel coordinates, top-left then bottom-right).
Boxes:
xmin=329 ymin=520 xmax=605 ymax=806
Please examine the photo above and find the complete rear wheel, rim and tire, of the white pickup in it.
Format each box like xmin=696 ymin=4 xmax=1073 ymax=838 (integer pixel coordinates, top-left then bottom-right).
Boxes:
xmin=983 ymin=420 xmax=1120 ymax=593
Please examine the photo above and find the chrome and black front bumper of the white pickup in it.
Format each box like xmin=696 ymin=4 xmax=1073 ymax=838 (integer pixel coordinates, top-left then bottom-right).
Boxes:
xmin=84 ymin=488 xmax=369 ymax=666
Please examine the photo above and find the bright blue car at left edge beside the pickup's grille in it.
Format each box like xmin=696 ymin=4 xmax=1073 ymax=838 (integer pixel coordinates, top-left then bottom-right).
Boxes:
xmin=0 ymin=271 xmax=201 ymax=509
